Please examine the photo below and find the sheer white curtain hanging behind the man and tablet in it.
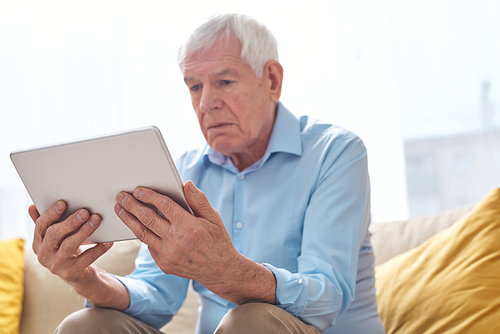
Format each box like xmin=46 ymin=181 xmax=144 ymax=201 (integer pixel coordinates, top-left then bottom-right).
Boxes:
xmin=0 ymin=0 xmax=432 ymax=240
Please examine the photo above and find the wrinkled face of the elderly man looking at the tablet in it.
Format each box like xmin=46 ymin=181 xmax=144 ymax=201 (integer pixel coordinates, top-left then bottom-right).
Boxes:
xmin=182 ymin=37 xmax=277 ymax=167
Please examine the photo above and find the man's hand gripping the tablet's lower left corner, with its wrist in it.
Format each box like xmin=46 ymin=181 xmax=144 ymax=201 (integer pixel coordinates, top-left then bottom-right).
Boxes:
xmin=28 ymin=201 xmax=129 ymax=310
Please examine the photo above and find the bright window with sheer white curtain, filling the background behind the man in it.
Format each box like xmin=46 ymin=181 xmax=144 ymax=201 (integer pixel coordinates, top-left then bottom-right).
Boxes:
xmin=0 ymin=0 xmax=500 ymax=239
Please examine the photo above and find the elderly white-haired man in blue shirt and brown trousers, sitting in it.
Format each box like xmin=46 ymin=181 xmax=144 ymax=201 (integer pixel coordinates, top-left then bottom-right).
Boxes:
xmin=29 ymin=15 xmax=384 ymax=334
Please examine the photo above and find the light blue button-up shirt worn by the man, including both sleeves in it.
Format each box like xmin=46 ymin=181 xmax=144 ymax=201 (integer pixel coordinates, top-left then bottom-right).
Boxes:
xmin=118 ymin=104 xmax=384 ymax=334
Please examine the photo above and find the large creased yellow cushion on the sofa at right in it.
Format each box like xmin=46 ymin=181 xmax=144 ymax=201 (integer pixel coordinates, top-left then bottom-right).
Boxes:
xmin=376 ymin=189 xmax=500 ymax=334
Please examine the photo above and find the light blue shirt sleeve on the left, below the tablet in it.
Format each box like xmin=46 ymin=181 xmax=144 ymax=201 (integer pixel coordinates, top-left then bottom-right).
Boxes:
xmin=109 ymin=244 xmax=189 ymax=329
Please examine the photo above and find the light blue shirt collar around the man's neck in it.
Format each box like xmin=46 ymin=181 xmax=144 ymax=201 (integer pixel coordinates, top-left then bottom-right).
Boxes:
xmin=203 ymin=102 xmax=302 ymax=173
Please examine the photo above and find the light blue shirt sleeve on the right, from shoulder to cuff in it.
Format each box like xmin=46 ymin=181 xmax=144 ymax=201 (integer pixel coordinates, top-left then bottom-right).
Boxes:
xmin=264 ymin=136 xmax=370 ymax=331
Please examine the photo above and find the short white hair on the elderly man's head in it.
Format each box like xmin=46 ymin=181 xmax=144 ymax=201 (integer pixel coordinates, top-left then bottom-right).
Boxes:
xmin=178 ymin=14 xmax=278 ymax=78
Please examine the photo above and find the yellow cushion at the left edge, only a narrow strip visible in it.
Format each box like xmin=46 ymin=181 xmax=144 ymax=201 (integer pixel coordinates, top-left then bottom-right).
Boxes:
xmin=0 ymin=239 xmax=24 ymax=334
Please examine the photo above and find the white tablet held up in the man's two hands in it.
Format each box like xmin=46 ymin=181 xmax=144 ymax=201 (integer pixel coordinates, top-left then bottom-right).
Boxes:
xmin=10 ymin=126 xmax=192 ymax=244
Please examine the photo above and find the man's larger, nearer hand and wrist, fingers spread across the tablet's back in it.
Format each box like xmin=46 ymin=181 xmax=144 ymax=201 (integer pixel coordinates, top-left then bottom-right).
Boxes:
xmin=115 ymin=181 xmax=276 ymax=304
